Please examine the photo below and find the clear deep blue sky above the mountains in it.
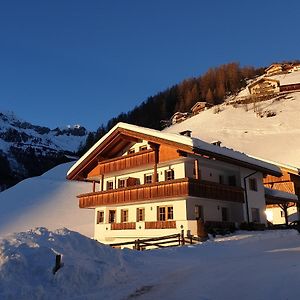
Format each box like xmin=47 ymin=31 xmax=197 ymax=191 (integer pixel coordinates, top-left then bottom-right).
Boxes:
xmin=0 ymin=0 xmax=300 ymax=129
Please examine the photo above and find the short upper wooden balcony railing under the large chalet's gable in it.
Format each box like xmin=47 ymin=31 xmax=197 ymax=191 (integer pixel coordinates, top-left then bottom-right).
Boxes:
xmin=97 ymin=150 xmax=155 ymax=175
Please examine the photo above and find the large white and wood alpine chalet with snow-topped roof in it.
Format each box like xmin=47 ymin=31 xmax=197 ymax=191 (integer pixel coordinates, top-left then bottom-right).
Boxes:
xmin=67 ymin=123 xmax=281 ymax=244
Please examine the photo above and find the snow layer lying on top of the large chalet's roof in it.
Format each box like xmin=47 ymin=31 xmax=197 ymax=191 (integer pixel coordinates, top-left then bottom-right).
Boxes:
xmin=67 ymin=122 xmax=281 ymax=176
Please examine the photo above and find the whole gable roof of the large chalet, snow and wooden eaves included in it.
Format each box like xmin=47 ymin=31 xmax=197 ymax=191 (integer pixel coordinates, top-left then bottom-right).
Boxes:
xmin=67 ymin=123 xmax=282 ymax=180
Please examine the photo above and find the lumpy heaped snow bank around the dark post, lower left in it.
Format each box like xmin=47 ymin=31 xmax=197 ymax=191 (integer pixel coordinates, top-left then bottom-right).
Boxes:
xmin=0 ymin=228 xmax=125 ymax=299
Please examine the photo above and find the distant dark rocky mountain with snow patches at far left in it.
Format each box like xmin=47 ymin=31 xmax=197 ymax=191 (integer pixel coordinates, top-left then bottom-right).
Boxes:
xmin=0 ymin=111 xmax=88 ymax=191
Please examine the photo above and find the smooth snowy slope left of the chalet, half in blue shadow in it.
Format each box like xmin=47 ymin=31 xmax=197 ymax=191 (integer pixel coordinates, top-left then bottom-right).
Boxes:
xmin=0 ymin=163 xmax=94 ymax=236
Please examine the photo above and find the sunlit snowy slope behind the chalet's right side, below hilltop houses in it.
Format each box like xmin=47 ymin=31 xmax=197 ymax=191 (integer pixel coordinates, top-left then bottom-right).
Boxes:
xmin=165 ymin=91 xmax=300 ymax=167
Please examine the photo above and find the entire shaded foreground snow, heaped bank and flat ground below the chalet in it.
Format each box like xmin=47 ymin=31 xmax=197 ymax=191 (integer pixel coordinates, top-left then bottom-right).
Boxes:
xmin=0 ymin=228 xmax=300 ymax=300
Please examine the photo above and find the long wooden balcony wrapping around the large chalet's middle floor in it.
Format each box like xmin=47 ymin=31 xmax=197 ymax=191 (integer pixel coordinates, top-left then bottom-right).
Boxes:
xmin=77 ymin=178 xmax=244 ymax=208
